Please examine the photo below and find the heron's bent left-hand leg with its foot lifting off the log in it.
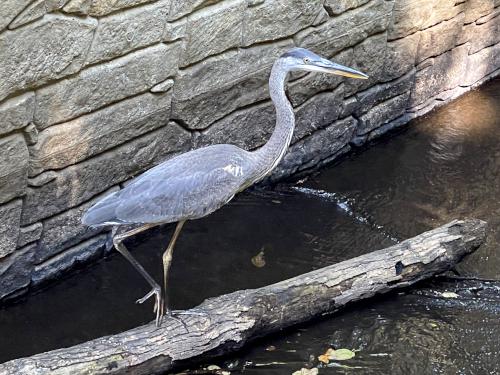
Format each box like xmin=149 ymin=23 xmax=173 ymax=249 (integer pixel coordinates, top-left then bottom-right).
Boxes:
xmin=113 ymin=225 xmax=164 ymax=327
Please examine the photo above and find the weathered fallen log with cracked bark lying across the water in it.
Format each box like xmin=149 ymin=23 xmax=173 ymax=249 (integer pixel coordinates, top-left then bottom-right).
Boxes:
xmin=0 ymin=219 xmax=486 ymax=375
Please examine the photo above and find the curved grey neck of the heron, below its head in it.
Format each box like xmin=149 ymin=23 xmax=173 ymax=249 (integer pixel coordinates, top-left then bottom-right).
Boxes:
xmin=255 ymin=60 xmax=295 ymax=179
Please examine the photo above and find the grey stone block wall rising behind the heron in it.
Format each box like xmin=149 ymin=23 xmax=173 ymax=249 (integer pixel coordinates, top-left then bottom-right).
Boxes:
xmin=0 ymin=0 xmax=500 ymax=299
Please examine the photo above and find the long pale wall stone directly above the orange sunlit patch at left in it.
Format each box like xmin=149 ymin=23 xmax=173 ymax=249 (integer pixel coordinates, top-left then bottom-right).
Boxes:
xmin=35 ymin=43 xmax=180 ymax=129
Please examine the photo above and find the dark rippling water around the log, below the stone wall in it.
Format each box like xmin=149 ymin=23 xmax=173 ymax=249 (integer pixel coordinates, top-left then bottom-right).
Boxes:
xmin=0 ymin=80 xmax=500 ymax=375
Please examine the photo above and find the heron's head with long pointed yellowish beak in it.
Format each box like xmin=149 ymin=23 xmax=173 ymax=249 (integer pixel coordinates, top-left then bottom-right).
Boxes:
xmin=281 ymin=48 xmax=368 ymax=79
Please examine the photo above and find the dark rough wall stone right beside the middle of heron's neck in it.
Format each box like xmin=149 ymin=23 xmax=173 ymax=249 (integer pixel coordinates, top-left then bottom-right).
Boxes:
xmin=292 ymin=85 xmax=344 ymax=143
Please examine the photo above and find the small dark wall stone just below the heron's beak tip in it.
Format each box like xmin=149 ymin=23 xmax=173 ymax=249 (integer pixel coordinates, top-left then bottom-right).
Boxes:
xmin=357 ymin=91 xmax=410 ymax=135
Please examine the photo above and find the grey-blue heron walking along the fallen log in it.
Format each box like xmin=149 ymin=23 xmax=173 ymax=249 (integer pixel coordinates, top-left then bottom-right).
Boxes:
xmin=82 ymin=48 xmax=368 ymax=326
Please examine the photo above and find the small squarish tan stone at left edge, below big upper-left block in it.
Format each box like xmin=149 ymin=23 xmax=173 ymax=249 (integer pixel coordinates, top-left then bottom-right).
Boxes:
xmin=0 ymin=92 xmax=35 ymax=135
